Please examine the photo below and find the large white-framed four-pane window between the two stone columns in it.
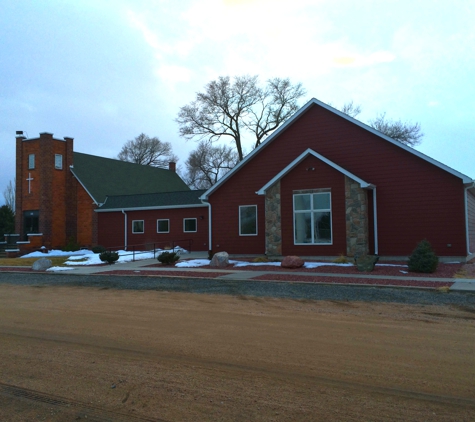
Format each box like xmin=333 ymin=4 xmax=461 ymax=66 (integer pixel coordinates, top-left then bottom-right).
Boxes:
xmin=294 ymin=190 xmax=333 ymax=245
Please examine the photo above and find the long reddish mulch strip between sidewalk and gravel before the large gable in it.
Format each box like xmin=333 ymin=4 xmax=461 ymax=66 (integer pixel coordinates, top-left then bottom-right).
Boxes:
xmin=252 ymin=274 xmax=454 ymax=289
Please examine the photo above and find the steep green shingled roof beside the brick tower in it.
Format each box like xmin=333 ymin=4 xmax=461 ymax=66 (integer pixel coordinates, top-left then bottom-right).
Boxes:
xmin=71 ymin=152 xmax=190 ymax=204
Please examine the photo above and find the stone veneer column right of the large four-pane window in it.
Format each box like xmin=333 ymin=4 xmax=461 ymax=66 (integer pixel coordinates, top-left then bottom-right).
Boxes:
xmin=345 ymin=176 xmax=369 ymax=256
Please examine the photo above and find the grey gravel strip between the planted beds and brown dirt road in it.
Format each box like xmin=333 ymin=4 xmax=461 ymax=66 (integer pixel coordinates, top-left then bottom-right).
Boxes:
xmin=0 ymin=272 xmax=475 ymax=310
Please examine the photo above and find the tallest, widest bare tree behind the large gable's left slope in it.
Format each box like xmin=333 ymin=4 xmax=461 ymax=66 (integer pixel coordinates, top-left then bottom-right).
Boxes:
xmin=176 ymin=75 xmax=305 ymax=160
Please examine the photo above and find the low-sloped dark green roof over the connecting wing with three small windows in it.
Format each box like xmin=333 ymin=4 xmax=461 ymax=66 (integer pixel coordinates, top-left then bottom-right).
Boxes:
xmin=97 ymin=190 xmax=206 ymax=212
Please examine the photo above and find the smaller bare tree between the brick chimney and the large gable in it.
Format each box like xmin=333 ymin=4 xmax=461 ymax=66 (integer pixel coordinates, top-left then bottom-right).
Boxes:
xmin=184 ymin=140 xmax=239 ymax=189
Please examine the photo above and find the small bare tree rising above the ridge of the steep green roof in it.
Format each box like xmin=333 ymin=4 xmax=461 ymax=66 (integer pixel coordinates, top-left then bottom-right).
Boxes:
xmin=117 ymin=133 xmax=178 ymax=168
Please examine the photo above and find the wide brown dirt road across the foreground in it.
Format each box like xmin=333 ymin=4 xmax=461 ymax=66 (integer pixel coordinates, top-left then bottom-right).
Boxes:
xmin=0 ymin=285 xmax=475 ymax=421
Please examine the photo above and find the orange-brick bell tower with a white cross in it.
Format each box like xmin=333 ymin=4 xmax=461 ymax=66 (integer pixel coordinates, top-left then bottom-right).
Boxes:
xmin=15 ymin=131 xmax=77 ymax=248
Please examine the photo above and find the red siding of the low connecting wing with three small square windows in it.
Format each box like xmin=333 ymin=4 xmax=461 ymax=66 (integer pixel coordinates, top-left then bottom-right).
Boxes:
xmin=97 ymin=207 xmax=208 ymax=251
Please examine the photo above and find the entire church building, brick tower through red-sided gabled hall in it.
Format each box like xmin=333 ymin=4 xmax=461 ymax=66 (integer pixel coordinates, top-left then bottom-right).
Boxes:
xmin=11 ymin=99 xmax=475 ymax=260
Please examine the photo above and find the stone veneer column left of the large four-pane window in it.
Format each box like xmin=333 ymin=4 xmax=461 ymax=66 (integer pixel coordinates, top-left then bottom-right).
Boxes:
xmin=266 ymin=181 xmax=282 ymax=256
